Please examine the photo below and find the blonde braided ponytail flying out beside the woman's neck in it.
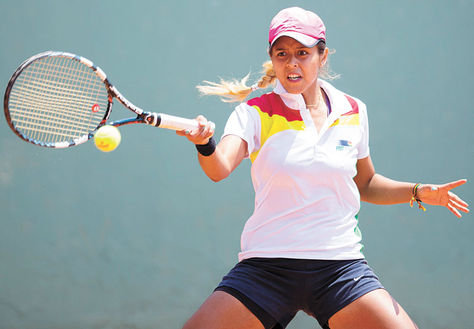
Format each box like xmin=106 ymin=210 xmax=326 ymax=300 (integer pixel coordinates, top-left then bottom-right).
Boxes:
xmin=197 ymin=61 xmax=276 ymax=103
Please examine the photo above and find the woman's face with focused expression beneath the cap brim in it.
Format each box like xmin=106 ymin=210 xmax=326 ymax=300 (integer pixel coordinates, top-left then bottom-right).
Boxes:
xmin=270 ymin=36 xmax=327 ymax=94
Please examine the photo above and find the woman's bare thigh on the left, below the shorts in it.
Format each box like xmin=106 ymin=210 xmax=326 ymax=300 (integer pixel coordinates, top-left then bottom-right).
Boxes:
xmin=183 ymin=291 xmax=264 ymax=329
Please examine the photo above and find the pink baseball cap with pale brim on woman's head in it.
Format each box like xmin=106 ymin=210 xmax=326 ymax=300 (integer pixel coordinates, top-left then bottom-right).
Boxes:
xmin=268 ymin=7 xmax=326 ymax=48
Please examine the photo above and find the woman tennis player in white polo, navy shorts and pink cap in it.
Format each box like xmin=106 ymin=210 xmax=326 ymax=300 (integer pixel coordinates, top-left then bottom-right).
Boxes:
xmin=178 ymin=7 xmax=469 ymax=329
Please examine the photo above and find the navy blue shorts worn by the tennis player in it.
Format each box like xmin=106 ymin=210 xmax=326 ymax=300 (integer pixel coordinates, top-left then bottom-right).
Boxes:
xmin=215 ymin=258 xmax=383 ymax=329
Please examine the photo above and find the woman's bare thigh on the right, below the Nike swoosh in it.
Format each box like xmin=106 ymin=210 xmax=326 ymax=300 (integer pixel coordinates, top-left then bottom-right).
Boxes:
xmin=329 ymin=289 xmax=418 ymax=329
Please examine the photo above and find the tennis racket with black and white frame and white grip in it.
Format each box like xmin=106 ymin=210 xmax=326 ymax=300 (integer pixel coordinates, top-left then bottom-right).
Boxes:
xmin=4 ymin=51 xmax=215 ymax=148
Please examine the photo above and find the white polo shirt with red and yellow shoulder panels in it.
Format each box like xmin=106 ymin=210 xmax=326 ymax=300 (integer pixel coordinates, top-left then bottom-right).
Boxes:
xmin=224 ymin=80 xmax=369 ymax=260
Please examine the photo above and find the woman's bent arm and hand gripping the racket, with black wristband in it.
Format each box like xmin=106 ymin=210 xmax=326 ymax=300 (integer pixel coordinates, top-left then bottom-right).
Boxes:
xmin=176 ymin=116 xmax=247 ymax=182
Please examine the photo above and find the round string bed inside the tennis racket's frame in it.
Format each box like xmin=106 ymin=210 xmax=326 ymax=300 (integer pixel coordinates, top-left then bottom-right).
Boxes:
xmin=9 ymin=56 xmax=108 ymax=143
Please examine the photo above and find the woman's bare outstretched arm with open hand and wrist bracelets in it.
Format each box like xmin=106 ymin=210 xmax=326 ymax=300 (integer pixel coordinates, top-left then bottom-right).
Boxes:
xmin=354 ymin=156 xmax=469 ymax=218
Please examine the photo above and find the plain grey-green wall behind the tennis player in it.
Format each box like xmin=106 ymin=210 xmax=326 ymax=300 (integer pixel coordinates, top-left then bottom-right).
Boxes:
xmin=0 ymin=0 xmax=474 ymax=329
